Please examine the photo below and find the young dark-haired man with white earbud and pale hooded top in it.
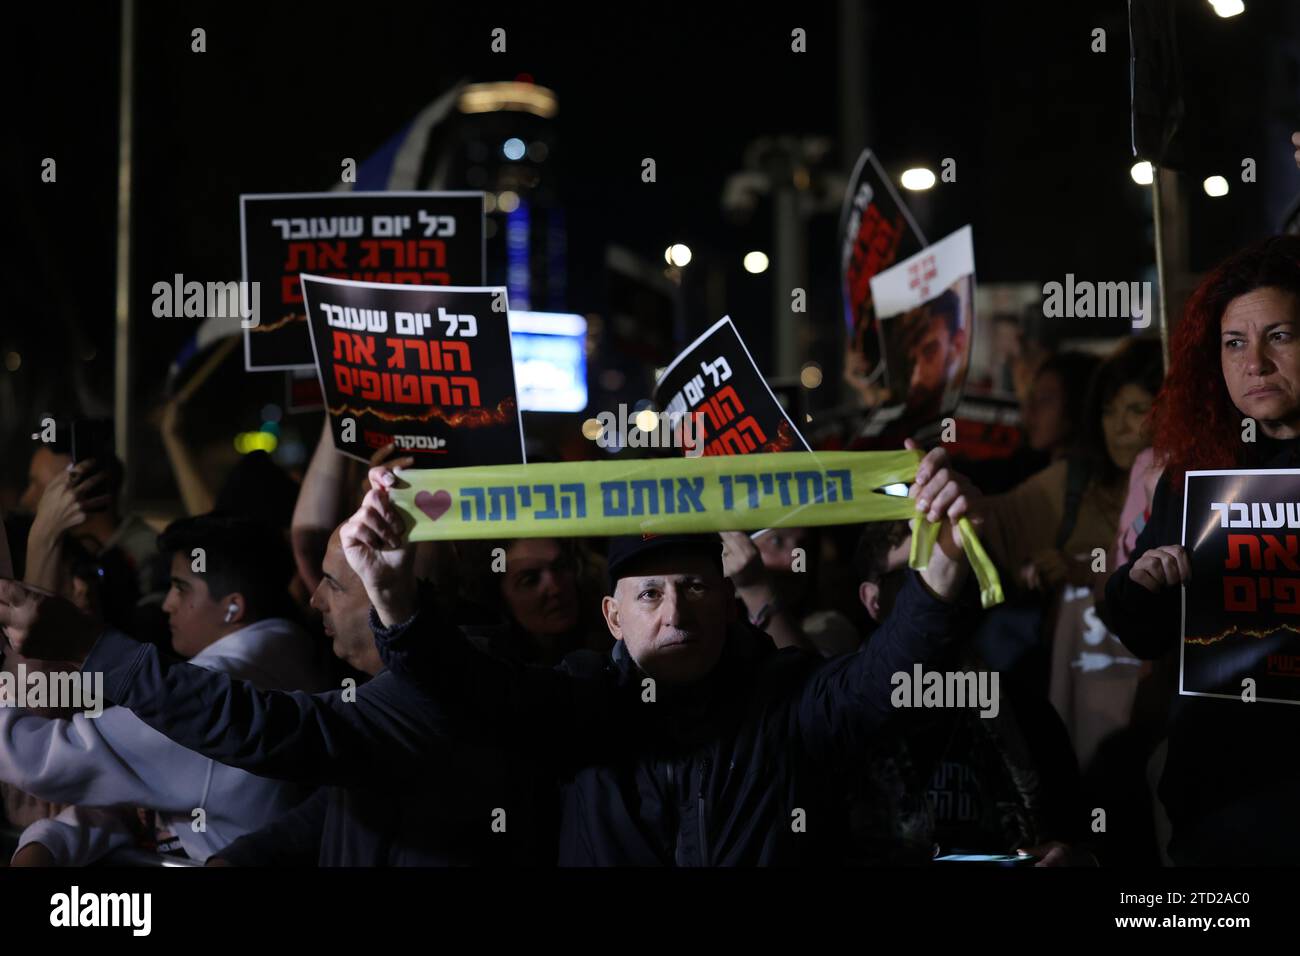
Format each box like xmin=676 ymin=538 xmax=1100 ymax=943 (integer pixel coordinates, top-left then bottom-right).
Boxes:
xmin=0 ymin=515 xmax=329 ymax=865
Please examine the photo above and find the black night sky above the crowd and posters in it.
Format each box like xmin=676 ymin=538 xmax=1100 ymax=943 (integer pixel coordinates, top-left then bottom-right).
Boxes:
xmin=0 ymin=0 xmax=1300 ymax=515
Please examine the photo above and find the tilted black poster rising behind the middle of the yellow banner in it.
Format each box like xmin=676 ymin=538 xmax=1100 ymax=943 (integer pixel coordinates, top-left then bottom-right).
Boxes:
xmin=654 ymin=316 xmax=813 ymax=455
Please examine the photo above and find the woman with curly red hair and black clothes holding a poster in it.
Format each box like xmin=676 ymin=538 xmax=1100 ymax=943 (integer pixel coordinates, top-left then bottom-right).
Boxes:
xmin=1099 ymin=235 xmax=1300 ymax=865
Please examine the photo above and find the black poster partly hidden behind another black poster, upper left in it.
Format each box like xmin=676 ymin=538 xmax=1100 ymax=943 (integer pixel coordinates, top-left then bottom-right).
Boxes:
xmin=239 ymin=193 xmax=485 ymax=372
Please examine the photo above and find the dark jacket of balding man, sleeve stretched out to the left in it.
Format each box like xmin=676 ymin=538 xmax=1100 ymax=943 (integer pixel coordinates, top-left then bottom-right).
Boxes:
xmin=83 ymin=631 xmax=555 ymax=866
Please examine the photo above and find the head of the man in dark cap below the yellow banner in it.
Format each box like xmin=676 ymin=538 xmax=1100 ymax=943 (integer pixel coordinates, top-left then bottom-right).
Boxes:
xmin=602 ymin=551 xmax=736 ymax=684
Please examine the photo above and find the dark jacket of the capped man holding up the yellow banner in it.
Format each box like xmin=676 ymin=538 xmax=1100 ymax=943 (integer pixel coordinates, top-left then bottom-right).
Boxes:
xmin=372 ymin=572 xmax=957 ymax=866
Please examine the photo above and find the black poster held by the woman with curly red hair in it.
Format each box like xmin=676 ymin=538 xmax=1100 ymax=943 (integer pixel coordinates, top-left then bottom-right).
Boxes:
xmin=1179 ymin=468 xmax=1300 ymax=704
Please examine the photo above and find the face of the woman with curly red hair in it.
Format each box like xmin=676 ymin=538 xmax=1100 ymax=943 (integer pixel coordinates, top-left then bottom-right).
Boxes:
xmin=1219 ymin=287 xmax=1300 ymax=438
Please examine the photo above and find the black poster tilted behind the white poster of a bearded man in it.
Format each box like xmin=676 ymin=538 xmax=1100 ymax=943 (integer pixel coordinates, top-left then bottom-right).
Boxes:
xmin=840 ymin=150 xmax=926 ymax=406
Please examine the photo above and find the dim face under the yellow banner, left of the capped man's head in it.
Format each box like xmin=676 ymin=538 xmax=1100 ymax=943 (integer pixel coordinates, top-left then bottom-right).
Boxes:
xmin=501 ymin=538 xmax=579 ymax=636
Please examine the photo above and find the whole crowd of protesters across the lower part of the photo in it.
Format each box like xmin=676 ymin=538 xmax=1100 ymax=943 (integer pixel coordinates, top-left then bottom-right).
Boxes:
xmin=0 ymin=230 xmax=1300 ymax=866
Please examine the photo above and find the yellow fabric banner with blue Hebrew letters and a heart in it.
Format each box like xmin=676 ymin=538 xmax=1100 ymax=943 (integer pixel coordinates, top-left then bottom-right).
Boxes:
xmin=391 ymin=451 xmax=1002 ymax=606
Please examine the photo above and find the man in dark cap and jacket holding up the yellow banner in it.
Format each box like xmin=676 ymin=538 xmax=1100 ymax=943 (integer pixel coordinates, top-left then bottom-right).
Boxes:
xmin=342 ymin=453 xmax=974 ymax=866
